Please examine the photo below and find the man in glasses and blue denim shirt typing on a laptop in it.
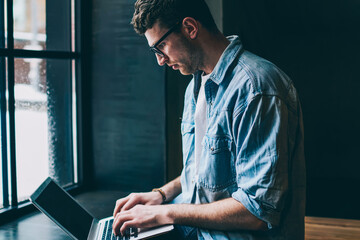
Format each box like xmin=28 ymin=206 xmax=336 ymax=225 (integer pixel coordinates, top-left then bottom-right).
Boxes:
xmin=113 ymin=0 xmax=305 ymax=239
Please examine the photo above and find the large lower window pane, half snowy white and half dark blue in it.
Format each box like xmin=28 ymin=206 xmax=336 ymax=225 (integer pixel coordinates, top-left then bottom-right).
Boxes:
xmin=15 ymin=58 xmax=73 ymax=201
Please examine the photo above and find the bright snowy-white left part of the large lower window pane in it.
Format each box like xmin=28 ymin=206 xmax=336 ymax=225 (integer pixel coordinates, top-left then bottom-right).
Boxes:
xmin=15 ymin=59 xmax=49 ymax=201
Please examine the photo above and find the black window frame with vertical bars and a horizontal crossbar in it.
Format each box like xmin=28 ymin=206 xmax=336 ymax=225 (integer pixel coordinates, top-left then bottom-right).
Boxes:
xmin=0 ymin=0 xmax=87 ymax=224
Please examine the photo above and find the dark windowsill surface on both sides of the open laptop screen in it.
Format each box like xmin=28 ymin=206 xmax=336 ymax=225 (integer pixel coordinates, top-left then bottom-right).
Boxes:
xmin=0 ymin=190 xmax=126 ymax=240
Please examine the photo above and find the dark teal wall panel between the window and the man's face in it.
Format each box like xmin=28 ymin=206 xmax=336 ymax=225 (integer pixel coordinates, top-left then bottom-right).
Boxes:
xmin=91 ymin=0 xmax=166 ymax=191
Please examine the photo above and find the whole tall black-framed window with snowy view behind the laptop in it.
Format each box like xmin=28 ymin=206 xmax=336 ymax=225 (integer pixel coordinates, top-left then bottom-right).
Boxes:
xmin=0 ymin=0 xmax=80 ymax=211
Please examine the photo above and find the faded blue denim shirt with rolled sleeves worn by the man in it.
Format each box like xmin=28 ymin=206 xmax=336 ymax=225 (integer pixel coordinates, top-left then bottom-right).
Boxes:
xmin=179 ymin=36 xmax=305 ymax=240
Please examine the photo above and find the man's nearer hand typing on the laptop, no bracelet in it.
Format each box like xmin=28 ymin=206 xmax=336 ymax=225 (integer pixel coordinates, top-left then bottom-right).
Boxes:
xmin=113 ymin=205 xmax=173 ymax=235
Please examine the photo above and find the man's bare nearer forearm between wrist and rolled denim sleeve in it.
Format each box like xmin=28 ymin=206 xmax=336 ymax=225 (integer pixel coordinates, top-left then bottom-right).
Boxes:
xmin=167 ymin=198 xmax=266 ymax=230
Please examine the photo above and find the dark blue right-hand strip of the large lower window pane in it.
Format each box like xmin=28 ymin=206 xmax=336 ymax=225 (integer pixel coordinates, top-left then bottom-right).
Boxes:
xmin=46 ymin=59 xmax=74 ymax=186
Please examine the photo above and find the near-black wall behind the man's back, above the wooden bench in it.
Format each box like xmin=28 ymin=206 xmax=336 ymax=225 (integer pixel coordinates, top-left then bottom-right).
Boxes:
xmin=223 ymin=0 xmax=360 ymax=219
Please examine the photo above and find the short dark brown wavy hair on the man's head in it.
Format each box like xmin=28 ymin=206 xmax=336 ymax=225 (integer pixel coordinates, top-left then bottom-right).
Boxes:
xmin=131 ymin=0 xmax=217 ymax=35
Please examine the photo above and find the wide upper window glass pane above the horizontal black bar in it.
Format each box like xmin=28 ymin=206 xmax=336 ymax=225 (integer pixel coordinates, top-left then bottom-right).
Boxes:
xmin=13 ymin=0 xmax=71 ymax=51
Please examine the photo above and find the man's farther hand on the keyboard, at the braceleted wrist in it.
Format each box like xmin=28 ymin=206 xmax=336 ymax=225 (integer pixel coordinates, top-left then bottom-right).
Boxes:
xmin=113 ymin=192 xmax=163 ymax=218
